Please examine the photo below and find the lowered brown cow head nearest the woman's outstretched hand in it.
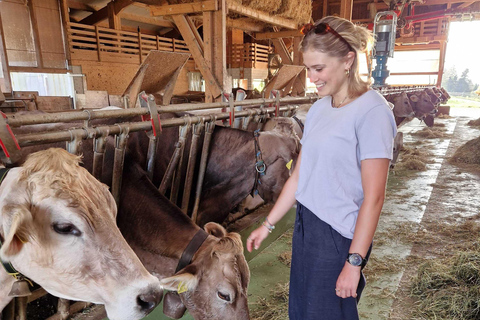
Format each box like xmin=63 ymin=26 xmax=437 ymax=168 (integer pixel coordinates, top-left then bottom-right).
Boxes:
xmin=161 ymin=222 xmax=250 ymax=320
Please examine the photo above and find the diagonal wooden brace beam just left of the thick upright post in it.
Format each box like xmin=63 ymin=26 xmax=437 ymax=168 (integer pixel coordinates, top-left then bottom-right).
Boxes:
xmin=172 ymin=15 xmax=222 ymax=98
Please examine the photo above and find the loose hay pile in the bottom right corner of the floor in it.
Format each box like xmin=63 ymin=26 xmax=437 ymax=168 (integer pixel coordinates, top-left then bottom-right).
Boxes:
xmin=411 ymin=251 xmax=480 ymax=320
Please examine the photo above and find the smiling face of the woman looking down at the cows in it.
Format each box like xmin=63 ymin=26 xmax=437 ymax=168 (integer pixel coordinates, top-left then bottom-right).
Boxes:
xmin=303 ymin=50 xmax=351 ymax=97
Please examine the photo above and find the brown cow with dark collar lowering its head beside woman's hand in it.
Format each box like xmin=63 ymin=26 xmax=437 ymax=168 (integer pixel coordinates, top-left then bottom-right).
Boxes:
xmin=0 ymin=120 xmax=254 ymax=320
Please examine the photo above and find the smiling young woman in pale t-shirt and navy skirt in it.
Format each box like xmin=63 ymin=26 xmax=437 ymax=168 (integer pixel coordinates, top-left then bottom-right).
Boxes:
xmin=247 ymin=17 xmax=396 ymax=320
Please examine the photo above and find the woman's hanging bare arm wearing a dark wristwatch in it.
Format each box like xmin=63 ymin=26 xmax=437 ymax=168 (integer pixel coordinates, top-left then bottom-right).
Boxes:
xmin=336 ymin=159 xmax=390 ymax=298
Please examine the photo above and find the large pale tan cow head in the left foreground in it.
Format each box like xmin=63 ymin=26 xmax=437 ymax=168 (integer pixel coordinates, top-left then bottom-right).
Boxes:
xmin=0 ymin=149 xmax=162 ymax=320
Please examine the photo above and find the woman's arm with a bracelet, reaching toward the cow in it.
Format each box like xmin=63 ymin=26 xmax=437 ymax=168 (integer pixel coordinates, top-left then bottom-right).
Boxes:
xmin=247 ymin=150 xmax=302 ymax=252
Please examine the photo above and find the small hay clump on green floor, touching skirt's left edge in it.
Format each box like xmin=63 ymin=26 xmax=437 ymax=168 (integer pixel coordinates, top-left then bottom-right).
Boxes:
xmin=250 ymin=282 xmax=290 ymax=320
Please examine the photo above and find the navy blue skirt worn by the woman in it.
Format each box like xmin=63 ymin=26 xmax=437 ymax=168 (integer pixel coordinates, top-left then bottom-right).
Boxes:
xmin=288 ymin=202 xmax=371 ymax=320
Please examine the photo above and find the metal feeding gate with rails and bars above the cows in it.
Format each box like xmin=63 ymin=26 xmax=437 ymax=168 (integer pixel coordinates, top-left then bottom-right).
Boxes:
xmin=0 ymin=91 xmax=317 ymax=320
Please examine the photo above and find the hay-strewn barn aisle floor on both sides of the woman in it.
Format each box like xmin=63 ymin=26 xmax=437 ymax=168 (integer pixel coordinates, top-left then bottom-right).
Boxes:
xmin=249 ymin=108 xmax=480 ymax=320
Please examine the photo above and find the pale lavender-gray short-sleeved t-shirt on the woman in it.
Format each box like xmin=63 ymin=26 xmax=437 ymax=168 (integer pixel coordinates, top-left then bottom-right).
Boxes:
xmin=295 ymin=90 xmax=397 ymax=239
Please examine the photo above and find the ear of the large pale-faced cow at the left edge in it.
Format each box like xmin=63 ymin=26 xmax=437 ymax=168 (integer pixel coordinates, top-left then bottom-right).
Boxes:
xmin=0 ymin=208 xmax=32 ymax=258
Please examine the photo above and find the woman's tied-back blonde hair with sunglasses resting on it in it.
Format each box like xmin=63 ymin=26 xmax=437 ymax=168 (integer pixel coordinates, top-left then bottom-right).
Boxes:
xmin=300 ymin=16 xmax=374 ymax=97
